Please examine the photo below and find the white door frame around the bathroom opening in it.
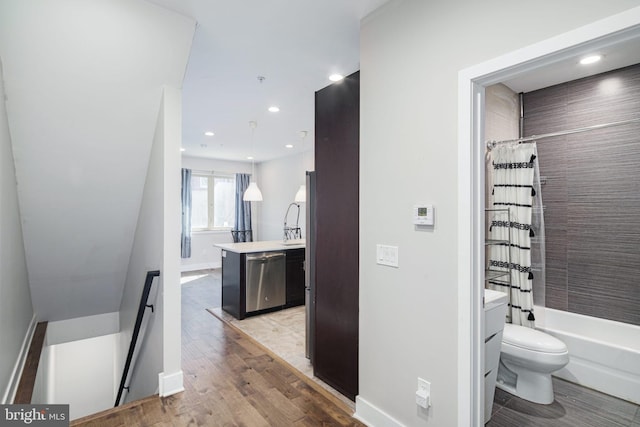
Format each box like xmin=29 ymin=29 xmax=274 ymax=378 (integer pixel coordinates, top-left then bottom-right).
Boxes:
xmin=458 ymin=7 xmax=640 ymax=427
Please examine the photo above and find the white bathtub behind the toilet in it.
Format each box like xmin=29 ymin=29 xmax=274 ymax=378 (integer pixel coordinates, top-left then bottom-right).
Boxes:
xmin=534 ymin=306 xmax=640 ymax=404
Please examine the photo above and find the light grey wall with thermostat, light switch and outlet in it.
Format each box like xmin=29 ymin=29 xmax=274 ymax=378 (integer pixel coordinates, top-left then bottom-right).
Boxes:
xmin=356 ymin=0 xmax=638 ymax=426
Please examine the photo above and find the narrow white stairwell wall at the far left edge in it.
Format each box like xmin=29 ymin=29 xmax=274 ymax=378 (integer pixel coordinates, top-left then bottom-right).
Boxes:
xmin=0 ymin=58 xmax=35 ymax=403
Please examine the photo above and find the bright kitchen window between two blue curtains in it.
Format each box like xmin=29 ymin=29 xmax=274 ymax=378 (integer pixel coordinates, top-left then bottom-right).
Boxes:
xmin=191 ymin=174 xmax=236 ymax=231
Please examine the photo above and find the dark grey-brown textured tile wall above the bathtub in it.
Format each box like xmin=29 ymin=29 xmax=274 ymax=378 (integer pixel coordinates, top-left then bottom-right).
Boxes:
xmin=523 ymin=61 xmax=640 ymax=325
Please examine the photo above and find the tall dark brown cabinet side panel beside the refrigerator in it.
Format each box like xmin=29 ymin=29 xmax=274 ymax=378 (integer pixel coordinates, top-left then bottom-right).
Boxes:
xmin=312 ymin=72 xmax=360 ymax=400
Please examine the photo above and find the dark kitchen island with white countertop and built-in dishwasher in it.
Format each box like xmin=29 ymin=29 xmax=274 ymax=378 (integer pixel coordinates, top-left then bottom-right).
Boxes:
xmin=216 ymin=239 xmax=305 ymax=319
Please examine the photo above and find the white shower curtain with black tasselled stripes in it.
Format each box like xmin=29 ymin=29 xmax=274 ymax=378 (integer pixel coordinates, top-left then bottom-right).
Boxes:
xmin=486 ymin=143 xmax=544 ymax=328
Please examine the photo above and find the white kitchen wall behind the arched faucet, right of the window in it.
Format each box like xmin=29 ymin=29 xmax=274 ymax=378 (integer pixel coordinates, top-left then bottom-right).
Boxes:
xmin=258 ymin=150 xmax=314 ymax=240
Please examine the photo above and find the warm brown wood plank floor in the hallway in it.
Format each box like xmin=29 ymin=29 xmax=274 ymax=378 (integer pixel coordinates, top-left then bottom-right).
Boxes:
xmin=71 ymin=274 xmax=363 ymax=427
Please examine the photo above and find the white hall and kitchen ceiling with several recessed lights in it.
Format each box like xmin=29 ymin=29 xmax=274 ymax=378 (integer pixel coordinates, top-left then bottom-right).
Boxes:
xmin=148 ymin=0 xmax=387 ymax=162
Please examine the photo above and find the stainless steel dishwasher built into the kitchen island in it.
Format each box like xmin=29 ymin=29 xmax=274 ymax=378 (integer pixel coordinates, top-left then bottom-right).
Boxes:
xmin=246 ymin=252 xmax=286 ymax=313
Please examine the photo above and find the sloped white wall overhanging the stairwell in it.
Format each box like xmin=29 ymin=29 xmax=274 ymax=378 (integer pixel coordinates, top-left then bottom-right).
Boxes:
xmin=0 ymin=0 xmax=195 ymax=321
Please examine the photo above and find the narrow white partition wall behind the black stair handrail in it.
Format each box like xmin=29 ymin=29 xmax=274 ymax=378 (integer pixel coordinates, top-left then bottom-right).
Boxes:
xmin=118 ymin=87 xmax=182 ymax=401
